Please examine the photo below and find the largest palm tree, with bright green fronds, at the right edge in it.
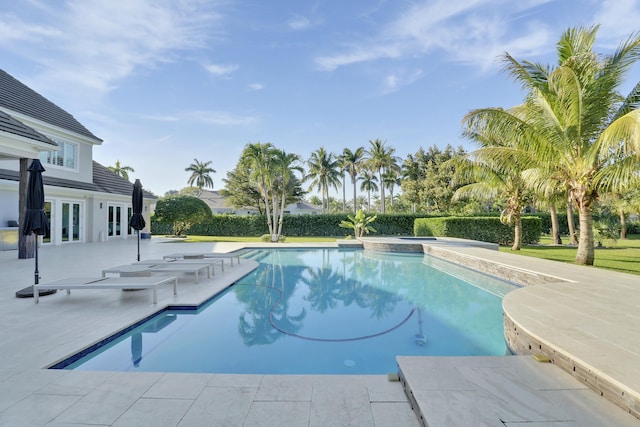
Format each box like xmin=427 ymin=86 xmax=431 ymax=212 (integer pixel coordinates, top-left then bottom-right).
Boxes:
xmin=465 ymin=26 xmax=640 ymax=265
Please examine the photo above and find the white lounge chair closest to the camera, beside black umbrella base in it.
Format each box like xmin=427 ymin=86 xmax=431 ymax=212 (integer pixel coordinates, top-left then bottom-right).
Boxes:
xmin=33 ymin=276 xmax=178 ymax=304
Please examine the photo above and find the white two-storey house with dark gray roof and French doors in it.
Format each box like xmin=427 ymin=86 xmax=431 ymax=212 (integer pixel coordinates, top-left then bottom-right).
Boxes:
xmin=0 ymin=69 xmax=156 ymax=250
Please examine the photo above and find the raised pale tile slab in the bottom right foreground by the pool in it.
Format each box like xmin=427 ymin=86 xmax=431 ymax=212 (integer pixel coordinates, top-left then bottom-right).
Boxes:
xmin=397 ymin=356 xmax=639 ymax=427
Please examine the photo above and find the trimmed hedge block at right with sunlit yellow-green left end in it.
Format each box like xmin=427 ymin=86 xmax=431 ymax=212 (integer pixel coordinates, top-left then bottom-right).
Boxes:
xmin=414 ymin=216 xmax=542 ymax=245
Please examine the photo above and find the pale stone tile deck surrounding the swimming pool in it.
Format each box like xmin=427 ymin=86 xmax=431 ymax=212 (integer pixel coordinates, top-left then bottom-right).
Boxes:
xmin=0 ymin=238 xmax=640 ymax=427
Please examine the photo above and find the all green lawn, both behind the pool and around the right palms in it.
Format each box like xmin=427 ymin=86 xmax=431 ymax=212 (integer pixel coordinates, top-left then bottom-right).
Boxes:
xmin=161 ymin=235 xmax=640 ymax=276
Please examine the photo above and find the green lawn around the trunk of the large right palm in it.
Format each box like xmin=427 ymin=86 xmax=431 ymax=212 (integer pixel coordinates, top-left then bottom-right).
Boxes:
xmin=500 ymin=235 xmax=640 ymax=275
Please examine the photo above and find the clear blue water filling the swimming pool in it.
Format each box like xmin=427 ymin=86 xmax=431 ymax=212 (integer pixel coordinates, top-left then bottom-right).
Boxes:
xmin=58 ymin=249 xmax=514 ymax=374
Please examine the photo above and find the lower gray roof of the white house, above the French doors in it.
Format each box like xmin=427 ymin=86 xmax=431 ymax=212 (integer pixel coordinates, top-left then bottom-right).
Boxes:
xmin=0 ymin=161 xmax=157 ymax=199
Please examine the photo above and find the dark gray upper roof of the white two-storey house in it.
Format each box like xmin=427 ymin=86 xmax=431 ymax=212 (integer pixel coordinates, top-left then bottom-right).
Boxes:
xmin=0 ymin=69 xmax=102 ymax=142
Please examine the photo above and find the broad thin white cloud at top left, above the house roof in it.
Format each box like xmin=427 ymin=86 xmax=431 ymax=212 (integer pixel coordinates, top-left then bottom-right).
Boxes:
xmin=0 ymin=0 xmax=220 ymax=94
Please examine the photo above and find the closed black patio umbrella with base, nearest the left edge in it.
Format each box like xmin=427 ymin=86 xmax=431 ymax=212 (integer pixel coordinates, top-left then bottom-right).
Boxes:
xmin=16 ymin=159 xmax=56 ymax=298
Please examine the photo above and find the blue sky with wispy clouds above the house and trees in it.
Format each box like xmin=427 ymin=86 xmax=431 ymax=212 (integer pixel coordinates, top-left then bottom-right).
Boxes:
xmin=0 ymin=0 xmax=640 ymax=196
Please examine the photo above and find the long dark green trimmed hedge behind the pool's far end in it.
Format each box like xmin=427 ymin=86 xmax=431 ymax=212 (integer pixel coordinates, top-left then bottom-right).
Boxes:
xmin=151 ymin=214 xmax=436 ymax=237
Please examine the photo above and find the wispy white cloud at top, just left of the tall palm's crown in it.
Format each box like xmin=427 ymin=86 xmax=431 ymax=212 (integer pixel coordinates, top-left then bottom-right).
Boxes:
xmin=315 ymin=0 xmax=550 ymax=71
